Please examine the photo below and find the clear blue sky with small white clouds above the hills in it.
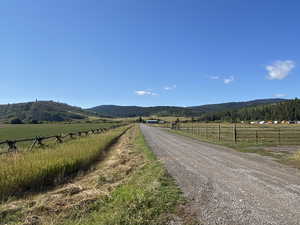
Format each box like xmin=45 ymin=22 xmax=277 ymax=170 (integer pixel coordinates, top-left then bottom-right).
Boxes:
xmin=0 ymin=0 xmax=300 ymax=107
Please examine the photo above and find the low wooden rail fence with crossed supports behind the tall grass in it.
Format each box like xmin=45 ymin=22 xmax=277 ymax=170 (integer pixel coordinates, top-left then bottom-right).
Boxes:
xmin=0 ymin=124 xmax=124 ymax=155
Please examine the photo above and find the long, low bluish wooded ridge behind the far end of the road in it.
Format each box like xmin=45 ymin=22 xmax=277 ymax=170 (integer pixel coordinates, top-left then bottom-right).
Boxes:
xmin=89 ymin=99 xmax=287 ymax=117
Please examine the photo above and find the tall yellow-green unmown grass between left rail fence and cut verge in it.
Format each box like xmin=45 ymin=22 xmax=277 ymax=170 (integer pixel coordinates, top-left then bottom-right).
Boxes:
xmin=0 ymin=127 xmax=127 ymax=200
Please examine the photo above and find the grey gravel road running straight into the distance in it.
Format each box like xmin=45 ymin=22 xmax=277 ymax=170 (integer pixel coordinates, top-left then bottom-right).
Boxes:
xmin=141 ymin=125 xmax=300 ymax=225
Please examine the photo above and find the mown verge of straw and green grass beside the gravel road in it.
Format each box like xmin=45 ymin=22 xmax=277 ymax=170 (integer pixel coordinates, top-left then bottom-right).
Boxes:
xmin=0 ymin=127 xmax=198 ymax=225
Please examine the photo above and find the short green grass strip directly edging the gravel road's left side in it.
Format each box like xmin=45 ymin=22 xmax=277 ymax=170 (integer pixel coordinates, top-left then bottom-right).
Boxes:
xmin=63 ymin=125 xmax=192 ymax=225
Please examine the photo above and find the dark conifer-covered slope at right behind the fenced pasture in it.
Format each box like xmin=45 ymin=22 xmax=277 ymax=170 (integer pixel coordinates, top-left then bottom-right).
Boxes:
xmin=199 ymin=99 xmax=300 ymax=122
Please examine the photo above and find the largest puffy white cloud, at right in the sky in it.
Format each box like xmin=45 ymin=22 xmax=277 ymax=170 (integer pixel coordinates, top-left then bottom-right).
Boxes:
xmin=266 ymin=60 xmax=295 ymax=80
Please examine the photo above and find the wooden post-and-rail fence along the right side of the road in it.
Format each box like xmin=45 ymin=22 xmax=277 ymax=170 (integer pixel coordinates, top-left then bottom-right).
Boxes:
xmin=172 ymin=123 xmax=300 ymax=145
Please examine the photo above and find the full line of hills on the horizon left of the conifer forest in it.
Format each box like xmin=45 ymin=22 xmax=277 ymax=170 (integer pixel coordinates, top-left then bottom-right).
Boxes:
xmin=0 ymin=98 xmax=287 ymax=123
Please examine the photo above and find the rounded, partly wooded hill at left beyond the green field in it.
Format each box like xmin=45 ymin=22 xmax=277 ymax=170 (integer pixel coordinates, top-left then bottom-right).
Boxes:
xmin=0 ymin=101 xmax=94 ymax=122
